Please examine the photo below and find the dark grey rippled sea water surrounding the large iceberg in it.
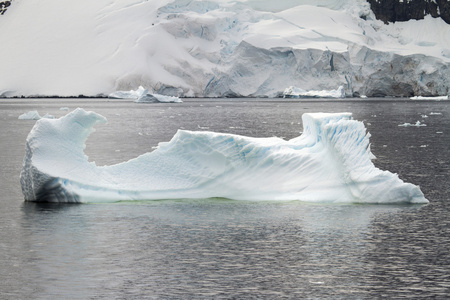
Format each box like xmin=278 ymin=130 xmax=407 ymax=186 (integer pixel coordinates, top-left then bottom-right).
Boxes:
xmin=0 ymin=99 xmax=450 ymax=299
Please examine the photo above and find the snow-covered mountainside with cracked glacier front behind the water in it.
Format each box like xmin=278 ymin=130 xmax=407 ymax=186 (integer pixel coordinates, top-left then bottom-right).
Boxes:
xmin=0 ymin=0 xmax=450 ymax=97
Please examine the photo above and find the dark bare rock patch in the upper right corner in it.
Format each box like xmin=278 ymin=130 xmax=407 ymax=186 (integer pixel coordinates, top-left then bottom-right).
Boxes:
xmin=367 ymin=0 xmax=450 ymax=24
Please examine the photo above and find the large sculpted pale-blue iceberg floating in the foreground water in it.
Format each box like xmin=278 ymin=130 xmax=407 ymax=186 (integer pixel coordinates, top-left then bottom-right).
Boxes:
xmin=20 ymin=109 xmax=428 ymax=203
